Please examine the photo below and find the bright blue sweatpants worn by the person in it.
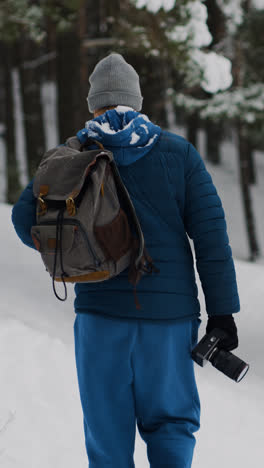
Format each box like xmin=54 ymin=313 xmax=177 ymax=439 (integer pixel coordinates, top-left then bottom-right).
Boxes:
xmin=74 ymin=313 xmax=201 ymax=468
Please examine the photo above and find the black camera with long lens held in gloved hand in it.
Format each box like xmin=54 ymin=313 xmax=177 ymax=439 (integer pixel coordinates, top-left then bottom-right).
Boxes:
xmin=191 ymin=328 xmax=249 ymax=382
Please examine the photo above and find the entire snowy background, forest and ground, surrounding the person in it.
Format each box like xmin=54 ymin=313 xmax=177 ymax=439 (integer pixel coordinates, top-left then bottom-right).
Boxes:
xmin=0 ymin=0 xmax=264 ymax=468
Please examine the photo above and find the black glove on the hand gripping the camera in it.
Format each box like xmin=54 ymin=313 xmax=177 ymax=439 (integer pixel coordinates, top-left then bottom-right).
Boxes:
xmin=206 ymin=315 xmax=238 ymax=351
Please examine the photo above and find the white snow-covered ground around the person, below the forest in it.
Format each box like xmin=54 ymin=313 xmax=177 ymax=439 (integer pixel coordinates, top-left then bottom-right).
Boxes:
xmin=0 ymin=133 xmax=264 ymax=468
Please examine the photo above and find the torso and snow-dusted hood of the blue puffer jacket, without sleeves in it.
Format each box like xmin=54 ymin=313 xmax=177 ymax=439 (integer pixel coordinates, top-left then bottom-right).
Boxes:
xmin=75 ymin=106 xmax=200 ymax=319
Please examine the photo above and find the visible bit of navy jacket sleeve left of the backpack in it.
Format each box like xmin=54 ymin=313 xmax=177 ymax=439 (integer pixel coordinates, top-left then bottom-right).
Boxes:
xmin=11 ymin=178 xmax=37 ymax=250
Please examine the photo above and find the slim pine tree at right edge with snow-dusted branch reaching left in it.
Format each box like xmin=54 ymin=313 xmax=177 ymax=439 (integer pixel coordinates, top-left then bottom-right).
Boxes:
xmin=172 ymin=2 xmax=264 ymax=261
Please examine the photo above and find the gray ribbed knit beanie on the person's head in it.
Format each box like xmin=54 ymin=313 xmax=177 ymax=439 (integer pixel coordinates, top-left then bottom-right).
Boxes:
xmin=87 ymin=53 xmax=143 ymax=113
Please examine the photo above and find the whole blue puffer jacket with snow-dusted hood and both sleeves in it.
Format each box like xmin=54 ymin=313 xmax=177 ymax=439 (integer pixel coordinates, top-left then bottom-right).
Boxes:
xmin=12 ymin=106 xmax=240 ymax=320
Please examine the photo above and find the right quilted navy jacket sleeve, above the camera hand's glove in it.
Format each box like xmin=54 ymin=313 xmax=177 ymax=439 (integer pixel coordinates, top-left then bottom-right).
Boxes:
xmin=184 ymin=143 xmax=240 ymax=316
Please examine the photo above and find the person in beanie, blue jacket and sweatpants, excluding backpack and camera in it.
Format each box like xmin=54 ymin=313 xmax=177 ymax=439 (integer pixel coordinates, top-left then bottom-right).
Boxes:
xmin=12 ymin=54 xmax=240 ymax=468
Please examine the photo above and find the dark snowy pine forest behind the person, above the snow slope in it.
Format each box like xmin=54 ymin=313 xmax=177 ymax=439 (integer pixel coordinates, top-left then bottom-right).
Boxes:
xmin=0 ymin=0 xmax=264 ymax=261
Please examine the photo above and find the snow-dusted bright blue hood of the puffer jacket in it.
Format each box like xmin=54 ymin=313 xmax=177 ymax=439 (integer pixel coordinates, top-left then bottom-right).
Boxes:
xmin=77 ymin=106 xmax=161 ymax=166
